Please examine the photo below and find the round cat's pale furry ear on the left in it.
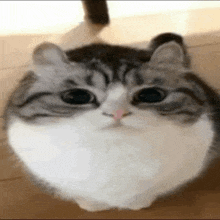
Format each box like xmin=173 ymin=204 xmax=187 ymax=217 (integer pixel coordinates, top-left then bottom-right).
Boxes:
xmin=32 ymin=42 xmax=69 ymax=66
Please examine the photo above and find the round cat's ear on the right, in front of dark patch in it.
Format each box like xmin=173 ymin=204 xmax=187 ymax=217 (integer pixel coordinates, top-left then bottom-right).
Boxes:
xmin=150 ymin=41 xmax=184 ymax=64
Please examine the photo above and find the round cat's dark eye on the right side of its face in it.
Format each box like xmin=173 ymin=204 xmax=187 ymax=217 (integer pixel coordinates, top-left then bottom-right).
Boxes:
xmin=135 ymin=88 xmax=166 ymax=103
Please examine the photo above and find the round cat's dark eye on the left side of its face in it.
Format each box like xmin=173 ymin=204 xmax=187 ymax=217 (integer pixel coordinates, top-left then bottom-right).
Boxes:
xmin=61 ymin=89 xmax=95 ymax=105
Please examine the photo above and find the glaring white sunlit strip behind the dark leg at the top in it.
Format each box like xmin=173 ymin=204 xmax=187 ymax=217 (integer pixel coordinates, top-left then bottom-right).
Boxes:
xmin=0 ymin=1 xmax=220 ymax=35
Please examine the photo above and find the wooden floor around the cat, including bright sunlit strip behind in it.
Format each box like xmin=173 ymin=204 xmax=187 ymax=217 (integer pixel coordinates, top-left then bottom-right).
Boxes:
xmin=0 ymin=0 xmax=220 ymax=219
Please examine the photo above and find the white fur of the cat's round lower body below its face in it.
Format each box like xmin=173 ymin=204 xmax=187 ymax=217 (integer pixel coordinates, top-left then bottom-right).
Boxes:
xmin=8 ymin=112 xmax=214 ymax=211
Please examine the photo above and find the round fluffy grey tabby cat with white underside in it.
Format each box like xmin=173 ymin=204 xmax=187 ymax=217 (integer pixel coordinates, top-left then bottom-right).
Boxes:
xmin=5 ymin=33 xmax=220 ymax=211
